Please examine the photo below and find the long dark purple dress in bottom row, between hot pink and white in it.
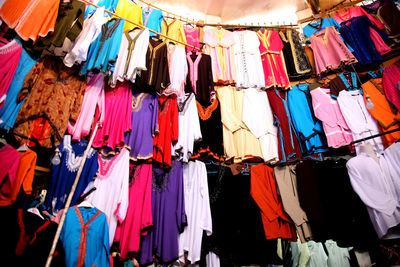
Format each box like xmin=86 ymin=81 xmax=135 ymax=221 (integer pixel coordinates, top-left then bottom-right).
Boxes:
xmin=140 ymin=160 xmax=187 ymax=265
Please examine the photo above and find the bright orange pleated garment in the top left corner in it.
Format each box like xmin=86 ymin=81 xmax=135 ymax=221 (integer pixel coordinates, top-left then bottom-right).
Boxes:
xmin=0 ymin=0 xmax=60 ymax=41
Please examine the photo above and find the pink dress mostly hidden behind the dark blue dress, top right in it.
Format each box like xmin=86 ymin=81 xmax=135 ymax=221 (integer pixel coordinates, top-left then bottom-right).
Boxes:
xmin=334 ymin=6 xmax=392 ymax=55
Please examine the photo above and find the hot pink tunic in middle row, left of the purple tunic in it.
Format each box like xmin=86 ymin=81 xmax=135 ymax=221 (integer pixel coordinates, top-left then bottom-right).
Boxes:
xmin=93 ymin=81 xmax=132 ymax=149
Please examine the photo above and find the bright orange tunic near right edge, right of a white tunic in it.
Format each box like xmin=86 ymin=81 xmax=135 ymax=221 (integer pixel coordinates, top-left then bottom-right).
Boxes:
xmin=362 ymin=78 xmax=400 ymax=147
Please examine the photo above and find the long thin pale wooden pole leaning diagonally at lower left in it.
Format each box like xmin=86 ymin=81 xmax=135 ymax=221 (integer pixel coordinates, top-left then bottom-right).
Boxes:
xmin=45 ymin=123 xmax=99 ymax=267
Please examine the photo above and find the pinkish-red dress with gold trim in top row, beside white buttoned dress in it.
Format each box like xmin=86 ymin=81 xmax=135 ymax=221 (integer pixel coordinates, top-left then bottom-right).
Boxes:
xmin=257 ymin=30 xmax=290 ymax=89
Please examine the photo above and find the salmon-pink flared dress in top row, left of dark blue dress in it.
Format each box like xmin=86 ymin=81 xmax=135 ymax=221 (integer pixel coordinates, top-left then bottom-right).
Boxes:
xmin=310 ymin=26 xmax=357 ymax=74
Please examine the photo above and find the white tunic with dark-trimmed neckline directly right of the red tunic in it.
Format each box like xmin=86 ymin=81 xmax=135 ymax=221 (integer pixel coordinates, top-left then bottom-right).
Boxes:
xmin=171 ymin=93 xmax=202 ymax=163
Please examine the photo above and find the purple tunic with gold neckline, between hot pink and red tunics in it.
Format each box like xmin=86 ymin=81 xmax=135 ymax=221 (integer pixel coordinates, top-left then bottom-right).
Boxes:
xmin=125 ymin=93 xmax=158 ymax=161
